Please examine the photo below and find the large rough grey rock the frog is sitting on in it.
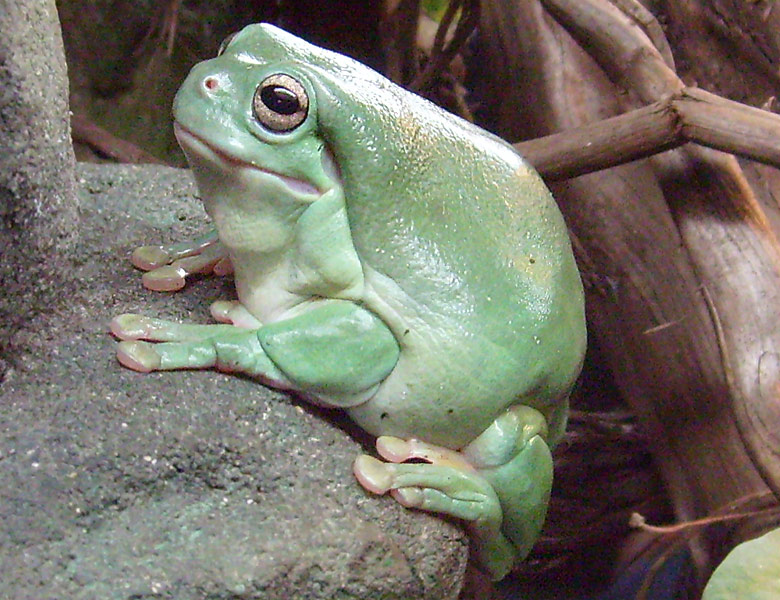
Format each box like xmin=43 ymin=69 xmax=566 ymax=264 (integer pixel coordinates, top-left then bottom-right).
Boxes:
xmin=0 ymin=166 xmax=467 ymax=600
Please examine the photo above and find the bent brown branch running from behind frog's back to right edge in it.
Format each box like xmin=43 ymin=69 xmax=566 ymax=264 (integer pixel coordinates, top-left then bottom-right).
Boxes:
xmin=515 ymin=88 xmax=780 ymax=181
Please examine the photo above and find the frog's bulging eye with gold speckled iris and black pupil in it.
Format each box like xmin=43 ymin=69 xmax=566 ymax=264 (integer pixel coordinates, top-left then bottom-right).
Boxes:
xmin=252 ymin=73 xmax=309 ymax=133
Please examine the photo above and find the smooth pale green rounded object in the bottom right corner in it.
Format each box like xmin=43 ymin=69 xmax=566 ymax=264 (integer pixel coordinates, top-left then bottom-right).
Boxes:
xmin=702 ymin=529 xmax=780 ymax=600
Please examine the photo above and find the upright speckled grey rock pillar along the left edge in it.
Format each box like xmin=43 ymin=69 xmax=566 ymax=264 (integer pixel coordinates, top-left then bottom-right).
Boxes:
xmin=0 ymin=0 xmax=77 ymax=370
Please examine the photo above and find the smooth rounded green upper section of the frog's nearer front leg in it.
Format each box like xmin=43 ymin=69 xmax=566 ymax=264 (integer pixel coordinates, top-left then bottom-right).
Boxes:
xmin=258 ymin=300 xmax=399 ymax=398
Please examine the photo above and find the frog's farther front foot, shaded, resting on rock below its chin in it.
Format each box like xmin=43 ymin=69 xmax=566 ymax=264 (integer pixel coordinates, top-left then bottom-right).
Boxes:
xmin=130 ymin=231 xmax=233 ymax=292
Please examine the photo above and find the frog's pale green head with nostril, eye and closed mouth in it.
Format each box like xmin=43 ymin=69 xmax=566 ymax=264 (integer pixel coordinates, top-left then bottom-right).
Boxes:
xmin=173 ymin=24 xmax=356 ymax=202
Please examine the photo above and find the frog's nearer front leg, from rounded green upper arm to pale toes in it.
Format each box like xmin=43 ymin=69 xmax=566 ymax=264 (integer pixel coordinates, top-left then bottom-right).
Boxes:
xmin=111 ymin=300 xmax=399 ymax=407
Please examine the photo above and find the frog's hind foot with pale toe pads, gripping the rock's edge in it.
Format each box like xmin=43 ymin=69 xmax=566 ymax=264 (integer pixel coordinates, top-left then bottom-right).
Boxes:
xmin=354 ymin=436 xmax=516 ymax=580
